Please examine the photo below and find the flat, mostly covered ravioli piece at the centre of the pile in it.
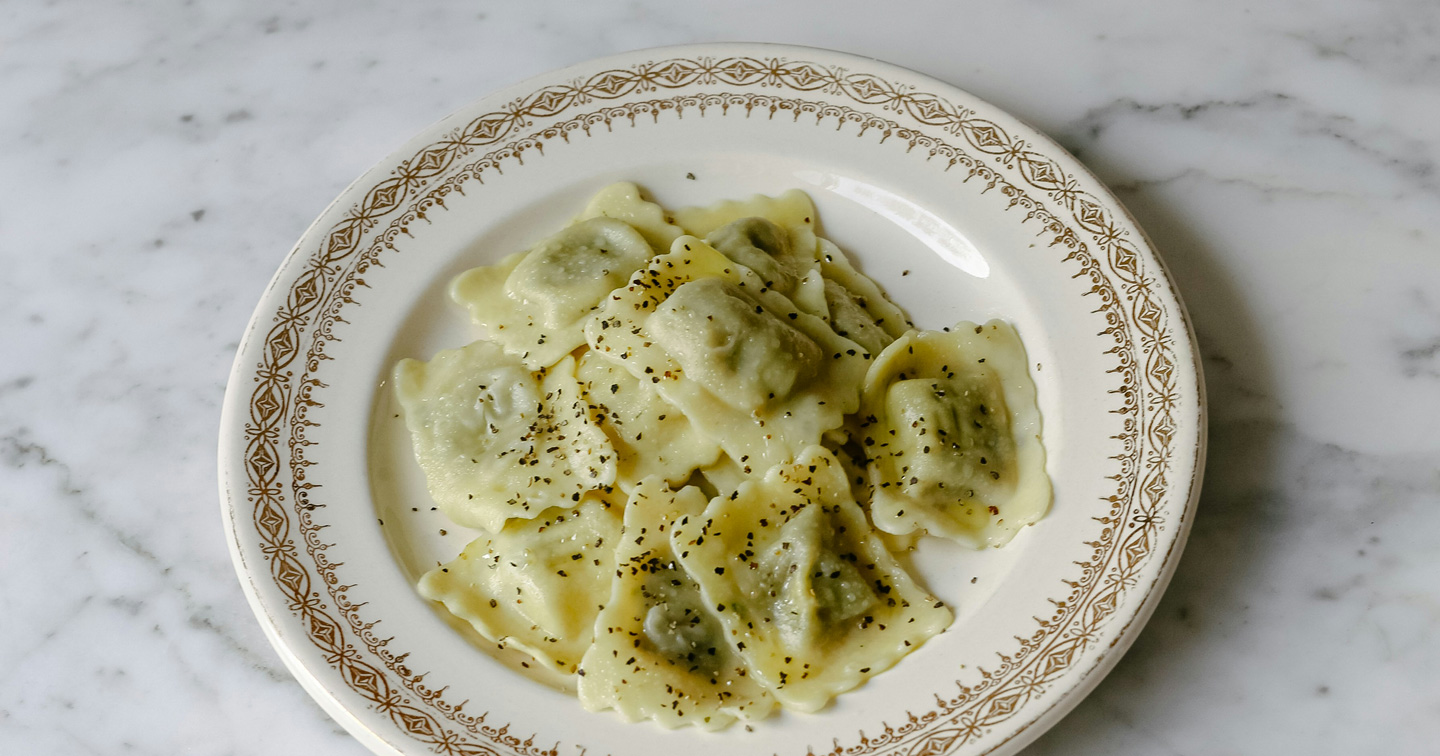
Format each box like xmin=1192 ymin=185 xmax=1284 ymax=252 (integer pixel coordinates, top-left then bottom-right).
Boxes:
xmin=576 ymin=351 xmax=720 ymax=490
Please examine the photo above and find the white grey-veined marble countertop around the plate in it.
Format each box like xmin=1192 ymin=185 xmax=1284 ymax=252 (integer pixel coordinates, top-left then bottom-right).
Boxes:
xmin=0 ymin=0 xmax=1440 ymax=756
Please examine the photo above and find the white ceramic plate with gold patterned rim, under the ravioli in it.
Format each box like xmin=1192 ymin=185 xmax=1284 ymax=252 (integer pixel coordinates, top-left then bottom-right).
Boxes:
xmin=220 ymin=45 xmax=1204 ymax=756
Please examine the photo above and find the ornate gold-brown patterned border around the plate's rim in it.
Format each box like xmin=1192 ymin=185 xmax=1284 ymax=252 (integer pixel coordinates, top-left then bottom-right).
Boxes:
xmin=245 ymin=58 xmax=1179 ymax=756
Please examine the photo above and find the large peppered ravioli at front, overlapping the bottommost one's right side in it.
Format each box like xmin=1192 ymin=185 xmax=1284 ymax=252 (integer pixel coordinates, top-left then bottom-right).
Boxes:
xmin=670 ymin=446 xmax=953 ymax=711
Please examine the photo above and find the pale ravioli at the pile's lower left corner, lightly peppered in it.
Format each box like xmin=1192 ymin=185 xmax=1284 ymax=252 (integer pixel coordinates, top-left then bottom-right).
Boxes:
xmin=419 ymin=497 xmax=621 ymax=674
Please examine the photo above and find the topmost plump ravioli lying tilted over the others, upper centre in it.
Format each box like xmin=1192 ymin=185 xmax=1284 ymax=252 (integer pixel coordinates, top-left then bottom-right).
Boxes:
xmin=586 ymin=236 xmax=870 ymax=469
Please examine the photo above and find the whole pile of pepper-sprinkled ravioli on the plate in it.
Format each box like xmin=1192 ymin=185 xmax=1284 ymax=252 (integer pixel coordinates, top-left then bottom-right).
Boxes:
xmin=393 ymin=183 xmax=1050 ymax=729
